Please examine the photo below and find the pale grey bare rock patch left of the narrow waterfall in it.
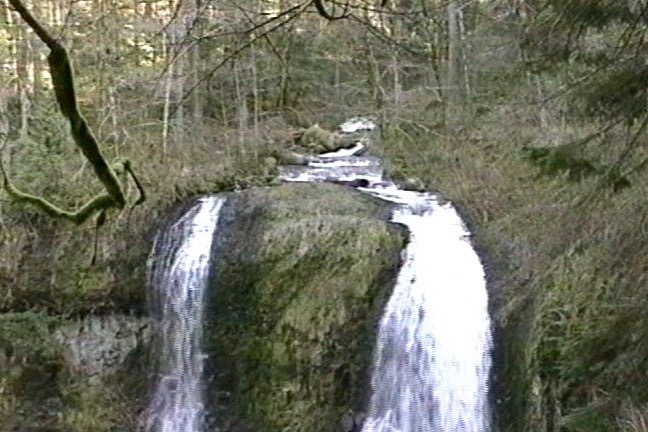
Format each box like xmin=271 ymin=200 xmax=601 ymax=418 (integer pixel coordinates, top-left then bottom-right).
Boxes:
xmin=54 ymin=314 xmax=150 ymax=382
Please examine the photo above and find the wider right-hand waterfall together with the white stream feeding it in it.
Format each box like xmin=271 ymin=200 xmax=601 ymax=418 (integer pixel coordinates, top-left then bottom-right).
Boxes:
xmin=281 ymin=119 xmax=492 ymax=432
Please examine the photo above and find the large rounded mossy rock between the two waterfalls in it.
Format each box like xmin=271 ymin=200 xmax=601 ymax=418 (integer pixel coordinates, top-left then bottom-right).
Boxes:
xmin=206 ymin=184 xmax=406 ymax=432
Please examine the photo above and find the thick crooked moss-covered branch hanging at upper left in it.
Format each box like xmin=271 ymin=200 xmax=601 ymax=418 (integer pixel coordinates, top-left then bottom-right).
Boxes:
xmin=2 ymin=0 xmax=146 ymax=224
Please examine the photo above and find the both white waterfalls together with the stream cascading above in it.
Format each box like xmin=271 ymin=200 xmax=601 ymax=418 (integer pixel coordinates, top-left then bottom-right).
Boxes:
xmin=145 ymin=119 xmax=492 ymax=432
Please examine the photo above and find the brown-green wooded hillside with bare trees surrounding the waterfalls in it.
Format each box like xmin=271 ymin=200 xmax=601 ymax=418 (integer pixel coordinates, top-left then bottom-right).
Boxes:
xmin=0 ymin=0 xmax=648 ymax=432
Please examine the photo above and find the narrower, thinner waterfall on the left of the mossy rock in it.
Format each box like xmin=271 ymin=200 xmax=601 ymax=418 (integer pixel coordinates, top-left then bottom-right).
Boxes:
xmin=143 ymin=196 xmax=225 ymax=432
